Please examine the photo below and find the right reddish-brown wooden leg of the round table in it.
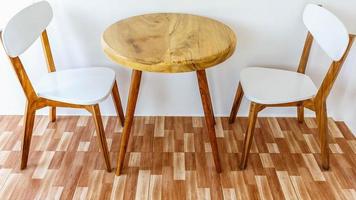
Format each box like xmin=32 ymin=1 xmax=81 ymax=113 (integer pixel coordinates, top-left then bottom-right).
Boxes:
xmin=197 ymin=70 xmax=221 ymax=173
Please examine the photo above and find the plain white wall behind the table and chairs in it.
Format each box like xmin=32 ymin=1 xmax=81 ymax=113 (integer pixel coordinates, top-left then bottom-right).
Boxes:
xmin=0 ymin=0 xmax=356 ymax=132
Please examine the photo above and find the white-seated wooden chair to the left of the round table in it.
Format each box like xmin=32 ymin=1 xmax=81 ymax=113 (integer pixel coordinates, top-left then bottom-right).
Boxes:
xmin=0 ymin=1 xmax=124 ymax=172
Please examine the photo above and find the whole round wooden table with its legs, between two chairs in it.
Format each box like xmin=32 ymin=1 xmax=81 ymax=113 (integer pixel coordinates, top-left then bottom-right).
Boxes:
xmin=102 ymin=13 xmax=236 ymax=175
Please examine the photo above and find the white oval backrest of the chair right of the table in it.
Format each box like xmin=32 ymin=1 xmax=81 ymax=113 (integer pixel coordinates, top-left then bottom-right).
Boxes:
xmin=303 ymin=4 xmax=349 ymax=61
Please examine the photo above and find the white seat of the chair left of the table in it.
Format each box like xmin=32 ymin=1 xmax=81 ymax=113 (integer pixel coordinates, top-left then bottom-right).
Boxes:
xmin=36 ymin=67 xmax=115 ymax=105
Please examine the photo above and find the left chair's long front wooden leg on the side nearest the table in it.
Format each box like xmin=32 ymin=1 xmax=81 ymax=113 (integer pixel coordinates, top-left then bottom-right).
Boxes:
xmin=91 ymin=104 xmax=111 ymax=172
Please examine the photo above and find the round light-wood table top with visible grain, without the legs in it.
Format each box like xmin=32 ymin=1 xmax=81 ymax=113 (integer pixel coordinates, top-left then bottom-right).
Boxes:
xmin=102 ymin=13 xmax=236 ymax=73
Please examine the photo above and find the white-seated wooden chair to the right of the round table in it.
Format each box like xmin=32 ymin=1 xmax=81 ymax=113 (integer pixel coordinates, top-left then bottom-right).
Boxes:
xmin=229 ymin=4 xmax=355 ymax=170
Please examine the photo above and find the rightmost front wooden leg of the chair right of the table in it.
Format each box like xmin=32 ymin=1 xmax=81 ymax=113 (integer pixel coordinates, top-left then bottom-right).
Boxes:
xmin=316 ymin=102 xmax=329 ymax=170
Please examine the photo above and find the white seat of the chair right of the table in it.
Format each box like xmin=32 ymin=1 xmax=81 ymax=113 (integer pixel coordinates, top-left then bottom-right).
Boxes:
xmin=240 ymin=67 xmax=317 ymax=104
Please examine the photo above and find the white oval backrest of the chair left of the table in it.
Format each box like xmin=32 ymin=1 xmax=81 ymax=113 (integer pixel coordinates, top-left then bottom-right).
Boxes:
xmin=2 ymin=1 xmax=53 ymax=57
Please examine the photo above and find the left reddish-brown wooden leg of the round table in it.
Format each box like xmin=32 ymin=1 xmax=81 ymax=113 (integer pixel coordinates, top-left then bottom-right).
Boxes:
xmin=116 ymin=70 xmax=142 ymax=176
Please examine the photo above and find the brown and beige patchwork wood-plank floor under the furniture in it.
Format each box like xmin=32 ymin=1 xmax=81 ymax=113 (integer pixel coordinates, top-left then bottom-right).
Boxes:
xmin=0 ymin=116 xmax=356 ymax=199
